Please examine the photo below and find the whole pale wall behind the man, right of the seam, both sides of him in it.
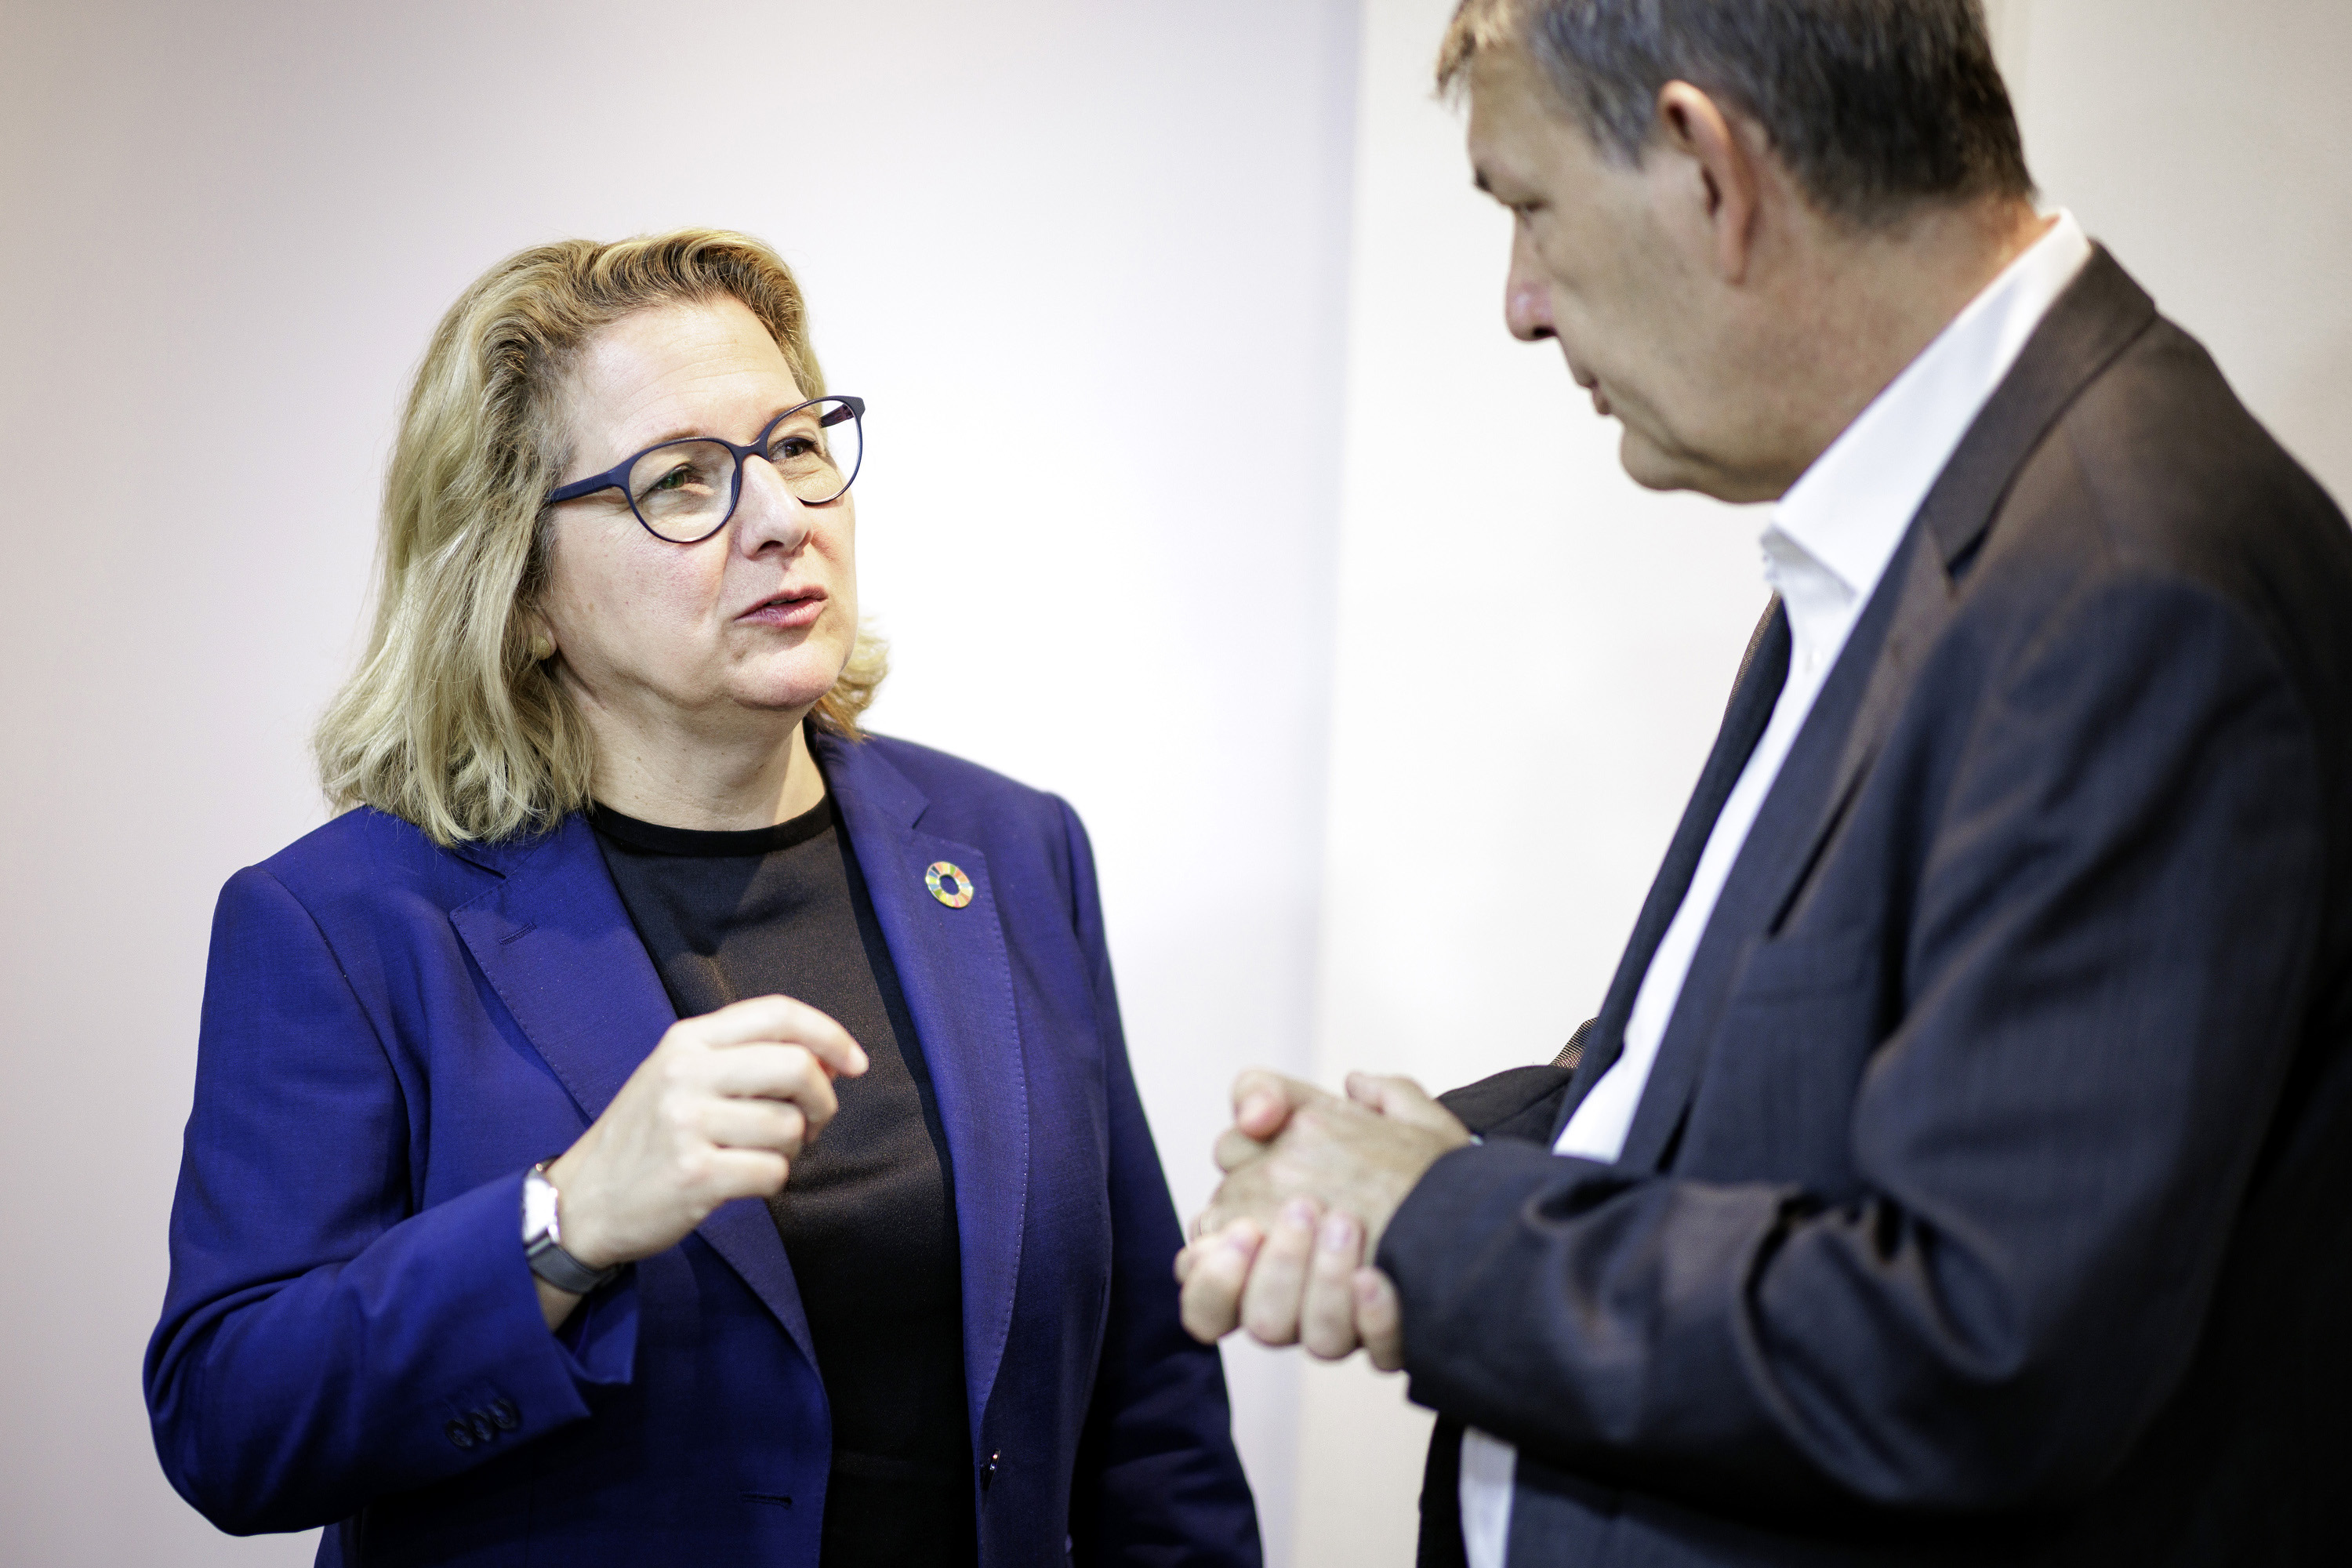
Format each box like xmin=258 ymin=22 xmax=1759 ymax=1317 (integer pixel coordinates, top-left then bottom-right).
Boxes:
xmin=1294 ymin=0 xmax=2352 ymax=1568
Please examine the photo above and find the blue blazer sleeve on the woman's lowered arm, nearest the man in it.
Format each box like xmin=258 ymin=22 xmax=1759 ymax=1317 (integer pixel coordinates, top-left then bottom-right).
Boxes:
xmin=1056 ymin=801 xmax=1258 ymax=1568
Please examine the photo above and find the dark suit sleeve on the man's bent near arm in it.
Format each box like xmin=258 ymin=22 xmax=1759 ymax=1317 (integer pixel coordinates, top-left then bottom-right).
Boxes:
xmin=1381 ymin=574 xmax=2326 ymax=1509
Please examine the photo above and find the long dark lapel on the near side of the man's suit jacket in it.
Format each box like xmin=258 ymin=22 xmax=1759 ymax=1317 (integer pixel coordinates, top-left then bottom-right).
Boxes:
xmin=1571 ymin=249 xmax=2154 ymax=1168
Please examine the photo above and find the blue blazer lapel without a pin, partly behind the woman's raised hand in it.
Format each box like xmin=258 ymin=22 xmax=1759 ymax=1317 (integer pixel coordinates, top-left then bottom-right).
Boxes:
xmin=449 ymin=813 xmax=816 ymax=1366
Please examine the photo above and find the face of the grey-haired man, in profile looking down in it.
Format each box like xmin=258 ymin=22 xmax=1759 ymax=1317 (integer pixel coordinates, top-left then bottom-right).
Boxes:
xmin=1470 ymin=45 xmax=1750 ymax=494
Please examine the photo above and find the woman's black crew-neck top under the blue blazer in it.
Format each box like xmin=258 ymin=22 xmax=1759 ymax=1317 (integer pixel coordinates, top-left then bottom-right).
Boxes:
xmin=588 ymin=797 xmax=978 ymax=1568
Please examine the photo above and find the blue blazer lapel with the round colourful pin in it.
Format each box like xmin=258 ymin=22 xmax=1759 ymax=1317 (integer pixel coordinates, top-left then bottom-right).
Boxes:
xmin=814 ymin=736 xmax=1030 ymax=1441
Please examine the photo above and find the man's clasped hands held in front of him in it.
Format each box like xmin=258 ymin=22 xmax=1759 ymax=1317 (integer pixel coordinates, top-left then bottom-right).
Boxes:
xmin=1176 ymin=1072 xmax=1470 ymax=1370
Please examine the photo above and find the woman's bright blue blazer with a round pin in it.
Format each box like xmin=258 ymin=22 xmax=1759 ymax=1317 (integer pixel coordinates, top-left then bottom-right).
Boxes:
xmin=146 ymin=739 xmax=1258 ymax=1568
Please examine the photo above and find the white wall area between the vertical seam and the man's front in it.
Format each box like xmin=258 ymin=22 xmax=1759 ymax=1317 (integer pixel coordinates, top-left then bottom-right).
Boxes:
xmin=1294 ymin=0 xmax=1766 ymax=1568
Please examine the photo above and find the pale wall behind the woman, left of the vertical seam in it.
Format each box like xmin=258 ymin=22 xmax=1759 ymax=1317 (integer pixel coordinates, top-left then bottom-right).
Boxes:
xmin=0 ymin=0 xmax=1355 ymax=1566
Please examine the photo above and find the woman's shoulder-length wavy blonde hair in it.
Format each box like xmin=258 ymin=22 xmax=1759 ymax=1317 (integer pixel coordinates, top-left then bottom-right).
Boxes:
xmin=315 ymin=228 xmax=887 ymax=844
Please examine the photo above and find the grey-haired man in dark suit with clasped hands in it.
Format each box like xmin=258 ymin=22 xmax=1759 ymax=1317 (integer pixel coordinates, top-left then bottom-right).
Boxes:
xmin=1178 ymin=0 xmax=2352 ymax=1568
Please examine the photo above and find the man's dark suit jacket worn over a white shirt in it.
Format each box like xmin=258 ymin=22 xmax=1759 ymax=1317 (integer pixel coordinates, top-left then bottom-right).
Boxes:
xmin=1381 ymin=252 xmax=2352 ymax=1566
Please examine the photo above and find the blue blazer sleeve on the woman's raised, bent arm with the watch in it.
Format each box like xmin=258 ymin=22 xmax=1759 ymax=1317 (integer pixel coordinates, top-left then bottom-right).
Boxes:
xmin=146 ymin=867 xmax=635 ymax=1535
